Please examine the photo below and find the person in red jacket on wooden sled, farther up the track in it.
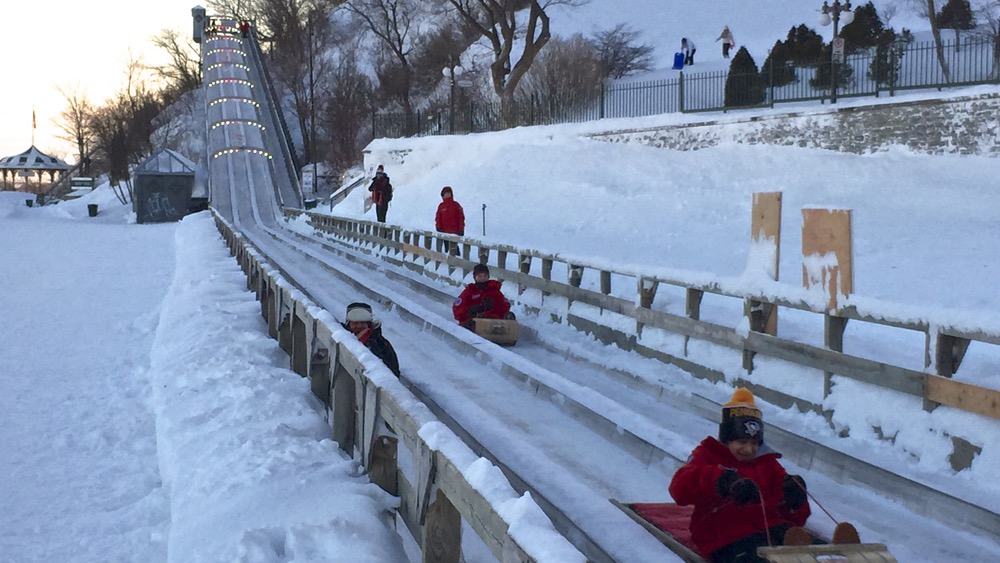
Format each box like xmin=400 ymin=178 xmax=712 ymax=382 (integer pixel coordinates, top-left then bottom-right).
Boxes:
xmin=451 ymin=264 xmax=519 ymax=346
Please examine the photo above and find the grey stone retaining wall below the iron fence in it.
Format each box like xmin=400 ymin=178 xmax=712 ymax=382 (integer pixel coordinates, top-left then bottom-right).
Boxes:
xmin=592 ymin=93 xmax=1000 ymax=157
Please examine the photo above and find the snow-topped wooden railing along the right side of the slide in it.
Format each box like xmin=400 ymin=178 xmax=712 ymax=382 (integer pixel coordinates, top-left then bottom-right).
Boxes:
xmin=294 ymin=210 xmax=1000 ymax=470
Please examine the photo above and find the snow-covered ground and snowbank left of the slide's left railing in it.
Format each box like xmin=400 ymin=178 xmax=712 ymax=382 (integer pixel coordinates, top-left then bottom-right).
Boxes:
xmin=0 ymin=189 xmax=406 ymax=563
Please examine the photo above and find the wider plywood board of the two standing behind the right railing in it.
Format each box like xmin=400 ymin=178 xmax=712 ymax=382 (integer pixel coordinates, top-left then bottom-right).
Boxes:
xmin=802 ymin=208 xmax=854 ymax=311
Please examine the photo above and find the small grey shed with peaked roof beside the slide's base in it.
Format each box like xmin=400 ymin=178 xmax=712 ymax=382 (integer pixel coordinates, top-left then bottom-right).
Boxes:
xmin=132 ymin=149 xmax=197 ymax=223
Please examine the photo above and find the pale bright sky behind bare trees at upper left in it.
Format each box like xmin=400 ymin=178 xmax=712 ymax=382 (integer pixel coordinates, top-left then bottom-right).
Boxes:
xmin=0 ymin=0 xmax=198 ymax=162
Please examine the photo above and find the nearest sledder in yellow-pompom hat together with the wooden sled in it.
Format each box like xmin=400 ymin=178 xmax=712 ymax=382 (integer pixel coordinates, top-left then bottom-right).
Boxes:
xmin=612 ymin=388 xmax=895 ymax=563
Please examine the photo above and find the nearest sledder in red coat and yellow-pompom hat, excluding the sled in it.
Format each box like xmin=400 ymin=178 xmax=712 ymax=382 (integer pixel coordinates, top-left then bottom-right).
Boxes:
xmin=670 ymin=388 xmax=810 ymax=563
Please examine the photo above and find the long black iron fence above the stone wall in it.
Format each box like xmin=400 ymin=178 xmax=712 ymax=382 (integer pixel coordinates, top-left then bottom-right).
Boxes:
xmin=372 ymin=36 xmax=1000 ymax=137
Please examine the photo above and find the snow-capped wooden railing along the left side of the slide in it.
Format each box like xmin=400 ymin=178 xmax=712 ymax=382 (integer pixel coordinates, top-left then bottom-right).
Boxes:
xmin=216 ymin=216 xmax=585 ymax=562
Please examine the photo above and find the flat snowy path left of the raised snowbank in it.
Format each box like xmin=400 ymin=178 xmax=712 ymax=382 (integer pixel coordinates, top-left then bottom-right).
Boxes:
xmin=0 ymin=220 xmax=175 ymax=562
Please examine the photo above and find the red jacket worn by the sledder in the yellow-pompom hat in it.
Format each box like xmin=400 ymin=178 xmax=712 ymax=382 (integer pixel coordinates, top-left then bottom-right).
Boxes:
xmin=670 ymin=436 xmax=810 ymax=558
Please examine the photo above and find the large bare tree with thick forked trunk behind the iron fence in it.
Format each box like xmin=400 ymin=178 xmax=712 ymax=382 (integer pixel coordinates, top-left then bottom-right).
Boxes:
xmin=448 ymin=0 xmax=586 ymax=124
